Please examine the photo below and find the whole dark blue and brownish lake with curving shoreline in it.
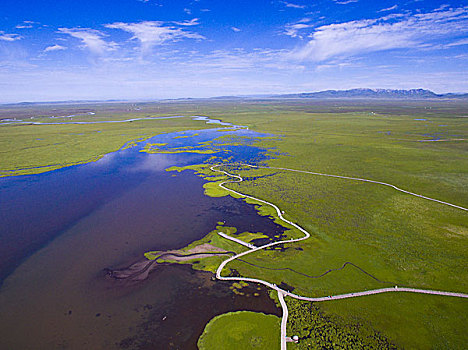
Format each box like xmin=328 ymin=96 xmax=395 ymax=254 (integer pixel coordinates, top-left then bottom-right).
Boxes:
xmin=0 ymin=121 xmax=283 ymax=350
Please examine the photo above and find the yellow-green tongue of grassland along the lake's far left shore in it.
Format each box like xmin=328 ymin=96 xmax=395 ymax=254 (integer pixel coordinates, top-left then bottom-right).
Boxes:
xmin=0 ymin=105 xmax=210 ymax=176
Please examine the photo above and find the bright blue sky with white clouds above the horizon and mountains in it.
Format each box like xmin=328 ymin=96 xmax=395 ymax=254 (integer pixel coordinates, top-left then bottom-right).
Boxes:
xmin=0 ymin=0 xmax=468 ymax=102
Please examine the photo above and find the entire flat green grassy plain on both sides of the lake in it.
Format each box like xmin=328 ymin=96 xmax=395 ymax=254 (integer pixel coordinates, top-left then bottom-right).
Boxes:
xmin=0 ymin=100 xmax=468 ymax=349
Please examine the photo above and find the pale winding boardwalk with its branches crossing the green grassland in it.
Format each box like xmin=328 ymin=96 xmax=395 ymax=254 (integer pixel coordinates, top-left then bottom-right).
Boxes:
xmin=210 ymin=164 xmax=468 ymax=350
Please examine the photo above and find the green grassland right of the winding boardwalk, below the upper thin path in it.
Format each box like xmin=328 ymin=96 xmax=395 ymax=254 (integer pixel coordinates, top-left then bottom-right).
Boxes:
xmin=170 ymin=161 xmax=468 ymax=349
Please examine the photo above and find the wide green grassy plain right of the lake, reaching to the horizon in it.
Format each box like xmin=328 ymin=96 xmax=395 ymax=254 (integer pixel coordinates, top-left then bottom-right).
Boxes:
xmin=196 ymin=102 xmax=468 ymax=349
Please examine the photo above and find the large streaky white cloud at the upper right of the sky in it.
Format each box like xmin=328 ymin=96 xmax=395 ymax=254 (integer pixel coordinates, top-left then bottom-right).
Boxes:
xmin=286 ymin=7 xmax=468 ymax=61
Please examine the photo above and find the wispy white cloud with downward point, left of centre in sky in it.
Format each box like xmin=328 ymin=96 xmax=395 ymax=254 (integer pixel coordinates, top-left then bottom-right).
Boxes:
xmin=105 ymin=19 xmax=205 ymax=53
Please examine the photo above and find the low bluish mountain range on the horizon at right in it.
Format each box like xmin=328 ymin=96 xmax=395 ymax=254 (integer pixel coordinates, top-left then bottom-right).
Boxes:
xmin=272 ymin=89 xmax=468 ymax=100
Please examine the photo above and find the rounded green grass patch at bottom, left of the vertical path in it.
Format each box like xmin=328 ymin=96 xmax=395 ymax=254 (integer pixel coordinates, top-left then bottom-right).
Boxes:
xmin=198 ymin=311 xmax=280 ymax=350
